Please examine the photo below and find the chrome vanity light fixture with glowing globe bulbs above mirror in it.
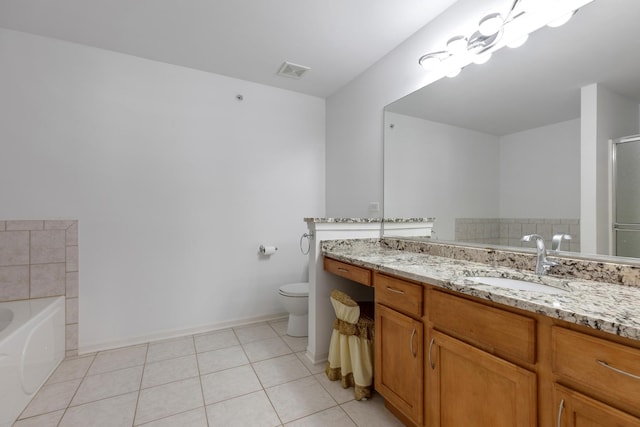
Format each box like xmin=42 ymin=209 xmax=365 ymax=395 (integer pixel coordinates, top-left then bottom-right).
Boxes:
xmin=418 ymin=0 xmax=592 ymax=77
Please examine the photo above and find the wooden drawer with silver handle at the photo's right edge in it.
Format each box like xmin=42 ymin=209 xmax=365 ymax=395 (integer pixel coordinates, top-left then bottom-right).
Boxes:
xmin=551 ymin=326 xmax=640 ymax=408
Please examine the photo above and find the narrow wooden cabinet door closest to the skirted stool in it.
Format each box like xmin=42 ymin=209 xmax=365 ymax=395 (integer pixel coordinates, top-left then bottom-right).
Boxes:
xmin=375 ymin=304 xmax=424 ymax=425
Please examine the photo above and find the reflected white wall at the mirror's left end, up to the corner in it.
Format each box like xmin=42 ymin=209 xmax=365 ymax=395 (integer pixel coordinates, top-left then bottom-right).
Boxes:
xmin=384 ymin=112 xmax=500 ymax=240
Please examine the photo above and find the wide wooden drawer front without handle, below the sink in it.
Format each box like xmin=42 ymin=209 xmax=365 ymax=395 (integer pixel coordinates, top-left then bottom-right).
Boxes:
xmin=428 ymin=290 xmax=536 ymax=364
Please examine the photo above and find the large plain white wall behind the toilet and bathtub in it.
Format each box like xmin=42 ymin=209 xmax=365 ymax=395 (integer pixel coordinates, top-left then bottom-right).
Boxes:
xmin=0 ymin=30 xmax=325 ymax=351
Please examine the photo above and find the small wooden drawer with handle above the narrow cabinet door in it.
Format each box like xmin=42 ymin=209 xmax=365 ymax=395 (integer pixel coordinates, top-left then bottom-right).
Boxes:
xmin=373 ymin=274 xmax=423 ymax=317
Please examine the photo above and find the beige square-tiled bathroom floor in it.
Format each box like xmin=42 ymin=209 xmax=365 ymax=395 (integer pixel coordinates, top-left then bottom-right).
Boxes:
xmin=14 ymin=320 xmax=402 ymax=427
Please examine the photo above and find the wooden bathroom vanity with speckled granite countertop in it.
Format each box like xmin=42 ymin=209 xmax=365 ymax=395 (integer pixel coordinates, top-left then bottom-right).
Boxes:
xmin=322 ymin=239 xmax=640 ymax=427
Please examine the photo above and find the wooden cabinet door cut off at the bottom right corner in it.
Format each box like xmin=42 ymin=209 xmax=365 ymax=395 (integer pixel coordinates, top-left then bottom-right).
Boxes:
xmin=553 ymin=384 xmax=640 ymax=427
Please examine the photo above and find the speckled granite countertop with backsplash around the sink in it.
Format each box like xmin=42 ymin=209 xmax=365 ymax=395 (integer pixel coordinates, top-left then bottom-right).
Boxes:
xmin=322 ymin=239 xmax=640 ymax=340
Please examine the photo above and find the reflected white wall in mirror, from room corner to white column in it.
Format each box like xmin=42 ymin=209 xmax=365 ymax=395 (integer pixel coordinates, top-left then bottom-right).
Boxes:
xmin=499 ymin=119 xmax=580 ymax=218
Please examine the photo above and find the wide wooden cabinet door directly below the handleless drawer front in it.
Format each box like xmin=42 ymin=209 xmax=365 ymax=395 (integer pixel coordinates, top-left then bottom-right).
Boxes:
xmin=425 ymin=330 xmax=537 ymax=427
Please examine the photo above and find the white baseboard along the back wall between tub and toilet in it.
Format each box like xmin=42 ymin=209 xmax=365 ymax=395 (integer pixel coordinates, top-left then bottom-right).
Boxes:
xmin=78 ymin=313 xmax=289 ymax=355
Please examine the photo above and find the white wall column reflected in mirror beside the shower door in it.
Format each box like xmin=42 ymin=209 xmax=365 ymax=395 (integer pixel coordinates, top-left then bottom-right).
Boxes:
xmin=580 ymin=84 xmax=639 ymax=254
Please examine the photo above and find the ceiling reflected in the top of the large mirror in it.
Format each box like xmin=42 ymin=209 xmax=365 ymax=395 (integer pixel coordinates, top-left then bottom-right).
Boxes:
xmin=387 ymin=0 xmax=640 ymax=135
